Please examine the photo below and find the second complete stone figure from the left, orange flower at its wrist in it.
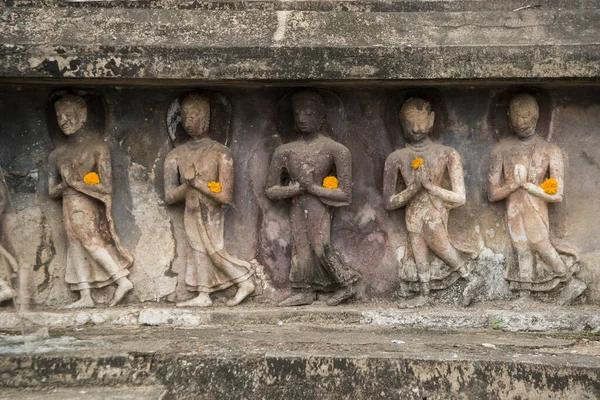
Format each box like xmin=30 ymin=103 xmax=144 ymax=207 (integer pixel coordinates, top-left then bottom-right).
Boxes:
xmin=164 ymin=94 xmax=255 ymax=307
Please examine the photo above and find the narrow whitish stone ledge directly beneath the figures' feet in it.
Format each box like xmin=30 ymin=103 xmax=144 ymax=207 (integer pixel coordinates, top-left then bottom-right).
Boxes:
xmin=0 ymin=306 xmax=600 ymax=332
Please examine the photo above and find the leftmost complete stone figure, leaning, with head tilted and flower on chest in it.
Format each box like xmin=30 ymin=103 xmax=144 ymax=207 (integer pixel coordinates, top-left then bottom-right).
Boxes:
xmin=49 ymin=94 xmax=134 ymax=308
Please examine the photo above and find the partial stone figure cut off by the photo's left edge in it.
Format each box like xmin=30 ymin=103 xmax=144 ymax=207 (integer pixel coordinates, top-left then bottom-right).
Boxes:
xmin=0 ymin=168 xmax=19 ymax=303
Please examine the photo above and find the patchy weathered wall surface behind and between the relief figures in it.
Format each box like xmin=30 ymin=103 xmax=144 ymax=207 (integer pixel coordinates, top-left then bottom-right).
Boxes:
xmin=0 ymin=84 xmax=600 ymax=306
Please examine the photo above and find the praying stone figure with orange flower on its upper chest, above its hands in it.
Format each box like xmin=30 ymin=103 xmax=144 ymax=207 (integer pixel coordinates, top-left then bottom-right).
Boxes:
xmin=383 ymin=98 xmax=483 ymax=307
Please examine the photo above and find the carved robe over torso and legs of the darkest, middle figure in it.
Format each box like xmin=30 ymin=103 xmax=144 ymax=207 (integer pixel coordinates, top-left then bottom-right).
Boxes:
xmin=269 ymin=136 xmax=361 ymax=291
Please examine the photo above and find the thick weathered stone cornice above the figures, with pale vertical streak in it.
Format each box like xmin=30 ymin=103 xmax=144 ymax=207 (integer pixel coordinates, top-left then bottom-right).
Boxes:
xmin=0 ymin=7 xmax=600 ymax=83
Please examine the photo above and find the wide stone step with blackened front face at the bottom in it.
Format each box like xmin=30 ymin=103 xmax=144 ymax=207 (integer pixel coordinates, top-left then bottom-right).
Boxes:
xmin=0 ymin=323 xmax=600 ymax=399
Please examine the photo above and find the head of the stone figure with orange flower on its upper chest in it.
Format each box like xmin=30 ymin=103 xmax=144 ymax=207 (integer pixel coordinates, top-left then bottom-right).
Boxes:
xmin=400 ymin=97 xmax=435 ymax=142
